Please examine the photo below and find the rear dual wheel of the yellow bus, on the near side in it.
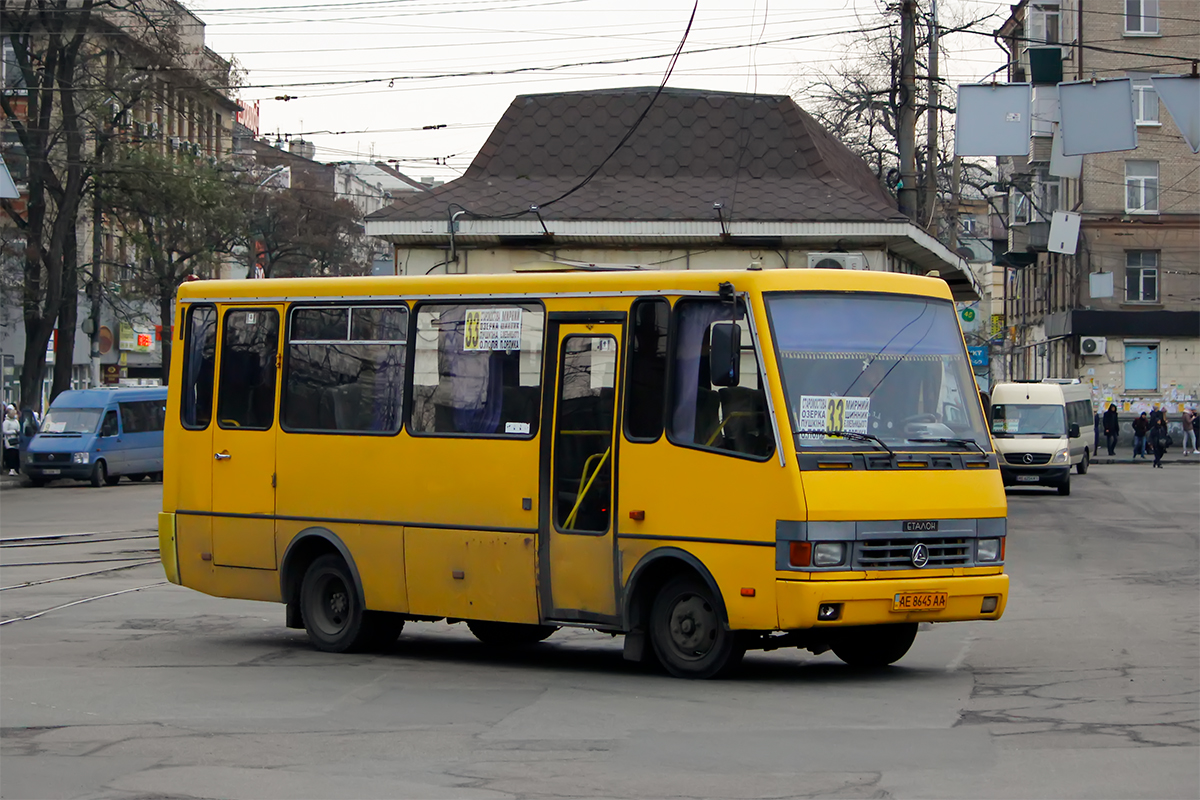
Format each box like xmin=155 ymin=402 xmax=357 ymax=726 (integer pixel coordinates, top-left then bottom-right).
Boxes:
xmin=300 ymin=553 xmax=404 ymax=652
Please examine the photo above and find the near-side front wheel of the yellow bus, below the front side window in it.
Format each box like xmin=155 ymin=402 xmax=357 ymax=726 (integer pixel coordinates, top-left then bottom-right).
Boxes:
xmin=649 ymin=576 xmax=746 ymax=679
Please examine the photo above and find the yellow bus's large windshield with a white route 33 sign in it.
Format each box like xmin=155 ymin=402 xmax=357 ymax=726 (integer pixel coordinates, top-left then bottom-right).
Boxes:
xmin=767 ymin=293 xmax=991 ymax=451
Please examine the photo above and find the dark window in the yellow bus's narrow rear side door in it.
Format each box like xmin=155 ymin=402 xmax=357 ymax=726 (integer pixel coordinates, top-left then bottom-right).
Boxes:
xmin=217 ymin=308 xmax=280 ymax=431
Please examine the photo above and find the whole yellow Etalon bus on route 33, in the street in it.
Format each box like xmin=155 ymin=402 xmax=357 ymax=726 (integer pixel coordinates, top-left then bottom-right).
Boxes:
xmin=158 ymin=265 xmax=1008 ymax=678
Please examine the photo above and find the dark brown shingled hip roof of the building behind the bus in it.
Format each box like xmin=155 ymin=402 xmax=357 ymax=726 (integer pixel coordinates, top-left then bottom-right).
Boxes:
xmin=371 ymin=88 xmax=904 ymax=222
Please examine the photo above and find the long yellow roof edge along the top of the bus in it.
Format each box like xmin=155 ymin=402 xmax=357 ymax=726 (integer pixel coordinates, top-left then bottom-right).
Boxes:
xmin=179 ymin=268 xmax=952 ymax=302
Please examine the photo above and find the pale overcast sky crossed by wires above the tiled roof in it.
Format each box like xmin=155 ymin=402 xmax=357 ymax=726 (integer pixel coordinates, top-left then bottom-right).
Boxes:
xmin=185 ymin=0 xmax=1007 ymax=180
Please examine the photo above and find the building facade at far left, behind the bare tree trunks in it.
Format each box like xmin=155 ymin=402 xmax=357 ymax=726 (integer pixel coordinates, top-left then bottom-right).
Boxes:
xmin=0 ymin=0 xmax=239 ymax=402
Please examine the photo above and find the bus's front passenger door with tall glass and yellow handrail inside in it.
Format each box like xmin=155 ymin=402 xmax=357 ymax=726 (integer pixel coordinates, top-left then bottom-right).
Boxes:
xmin=540 ymin=324 xmax=622 ymax=622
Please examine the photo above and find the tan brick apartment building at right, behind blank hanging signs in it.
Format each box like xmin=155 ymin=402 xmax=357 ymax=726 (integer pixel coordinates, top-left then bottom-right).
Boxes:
xmin=997 ymin=0 xmax=1200 ymax=422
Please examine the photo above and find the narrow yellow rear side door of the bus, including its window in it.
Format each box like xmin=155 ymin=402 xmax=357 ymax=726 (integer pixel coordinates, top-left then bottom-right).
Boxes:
xmin=210 ymin=307 xmax=282 ymax=570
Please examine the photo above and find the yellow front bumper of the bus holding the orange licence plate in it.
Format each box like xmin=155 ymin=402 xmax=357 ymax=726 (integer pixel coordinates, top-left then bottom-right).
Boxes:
xmin=775 ymin=575 xmax=1008 ymax=631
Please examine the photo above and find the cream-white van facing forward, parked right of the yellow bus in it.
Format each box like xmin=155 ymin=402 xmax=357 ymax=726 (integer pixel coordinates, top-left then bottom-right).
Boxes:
xmin=988 ymin=380 xmax=1094 ymax=494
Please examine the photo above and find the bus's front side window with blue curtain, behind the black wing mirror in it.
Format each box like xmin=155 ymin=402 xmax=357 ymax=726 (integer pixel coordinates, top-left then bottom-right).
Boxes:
xmin=667 ymin=300 xmax=775 ymax=459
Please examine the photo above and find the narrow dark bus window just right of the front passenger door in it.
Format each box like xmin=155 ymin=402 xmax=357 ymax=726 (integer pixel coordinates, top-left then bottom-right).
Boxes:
xmin=625 ymin=297 xmax=671 ymax=441
